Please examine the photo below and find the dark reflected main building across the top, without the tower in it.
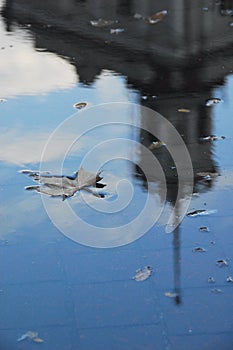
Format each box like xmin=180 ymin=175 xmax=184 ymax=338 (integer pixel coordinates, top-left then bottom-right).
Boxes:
xmin=3 ymin=0 xmax=232 ymax=93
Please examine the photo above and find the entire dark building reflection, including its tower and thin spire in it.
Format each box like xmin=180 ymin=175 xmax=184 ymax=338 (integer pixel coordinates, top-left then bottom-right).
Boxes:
xmin=2 ymin=0 xmax=233 ymax=304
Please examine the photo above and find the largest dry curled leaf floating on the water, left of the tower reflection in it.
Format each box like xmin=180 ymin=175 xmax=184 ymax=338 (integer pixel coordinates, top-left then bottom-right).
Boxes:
xmin=23 ymin=168 xmax=106 ymax=200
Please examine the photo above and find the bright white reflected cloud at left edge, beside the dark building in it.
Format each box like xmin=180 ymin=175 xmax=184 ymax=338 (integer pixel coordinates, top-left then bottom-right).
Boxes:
xmin=0 ymin=22 xmax=77 ymax=98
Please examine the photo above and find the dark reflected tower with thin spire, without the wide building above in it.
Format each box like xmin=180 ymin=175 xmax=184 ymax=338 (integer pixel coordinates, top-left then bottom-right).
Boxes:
xmin=136 ymin=93 xmax=216 ymax=304
